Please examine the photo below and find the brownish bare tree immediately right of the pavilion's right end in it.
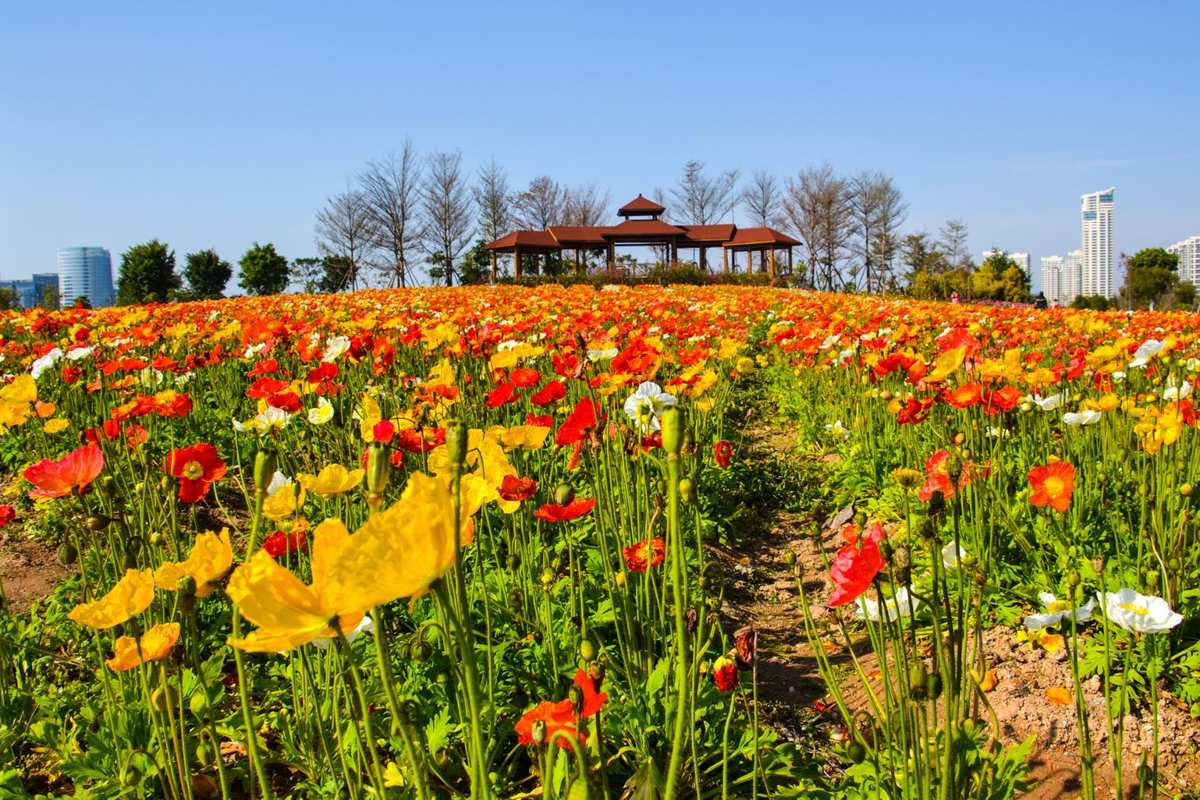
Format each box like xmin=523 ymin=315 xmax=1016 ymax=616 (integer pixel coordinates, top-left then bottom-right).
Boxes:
xmin=784 ymin=164 xmax=853 ymax=291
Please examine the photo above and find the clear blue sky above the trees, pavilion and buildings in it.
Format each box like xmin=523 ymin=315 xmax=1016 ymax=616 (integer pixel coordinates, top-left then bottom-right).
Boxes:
xmin=0 ymin=1 xmax=1200 ymax=291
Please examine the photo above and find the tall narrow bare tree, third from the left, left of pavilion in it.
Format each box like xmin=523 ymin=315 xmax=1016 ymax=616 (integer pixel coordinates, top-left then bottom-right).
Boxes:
xmin=421 ymin=152 xmax=472 ymax=287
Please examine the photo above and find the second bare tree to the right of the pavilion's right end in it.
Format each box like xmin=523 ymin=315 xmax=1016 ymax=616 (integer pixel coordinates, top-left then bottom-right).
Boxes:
xmin=847 ymin=172 xmax=907 ymax=291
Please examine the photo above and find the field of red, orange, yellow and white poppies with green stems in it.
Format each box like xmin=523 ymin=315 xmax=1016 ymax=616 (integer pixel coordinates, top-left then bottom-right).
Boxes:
xmin=0 ymin=287 xmax=1200 ymax=800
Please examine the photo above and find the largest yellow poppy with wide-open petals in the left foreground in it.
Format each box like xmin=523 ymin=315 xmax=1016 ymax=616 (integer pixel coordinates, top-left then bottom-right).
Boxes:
xmin=228 ymin=473 xmax=473 ymax=652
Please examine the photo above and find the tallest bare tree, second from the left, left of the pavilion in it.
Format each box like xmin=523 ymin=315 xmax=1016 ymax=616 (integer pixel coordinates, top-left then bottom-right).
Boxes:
xmin=359 ymin=140 xmax=422 ymax=287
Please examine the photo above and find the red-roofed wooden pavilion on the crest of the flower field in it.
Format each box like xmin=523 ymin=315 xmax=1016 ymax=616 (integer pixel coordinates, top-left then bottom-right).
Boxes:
xmin=486 ymin=194 xmax=800 ymax=282
